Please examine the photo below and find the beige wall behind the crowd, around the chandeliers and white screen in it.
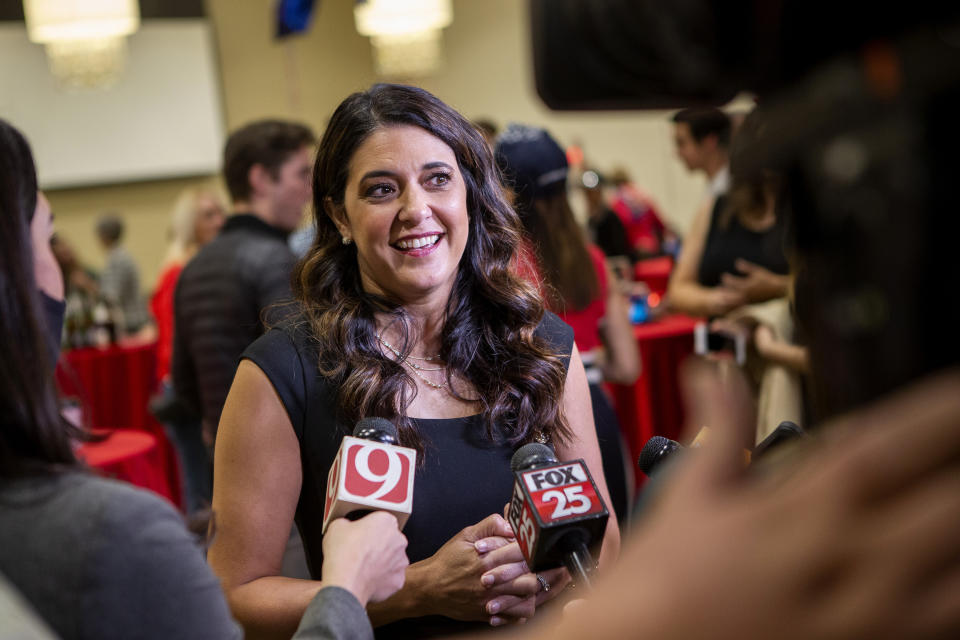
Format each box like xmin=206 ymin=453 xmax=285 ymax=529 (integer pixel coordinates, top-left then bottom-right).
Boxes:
xmin=48 ymin=0 xmax=703 ymax=290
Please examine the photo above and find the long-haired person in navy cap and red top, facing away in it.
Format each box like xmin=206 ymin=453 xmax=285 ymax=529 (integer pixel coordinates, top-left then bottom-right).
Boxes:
xmin=495 ymin=124 xmax=640 ymax=527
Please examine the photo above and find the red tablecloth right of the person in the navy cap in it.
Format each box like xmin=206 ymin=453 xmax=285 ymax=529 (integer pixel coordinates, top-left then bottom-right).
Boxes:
xmin=610 ymin=316 xmax=698 ymax=479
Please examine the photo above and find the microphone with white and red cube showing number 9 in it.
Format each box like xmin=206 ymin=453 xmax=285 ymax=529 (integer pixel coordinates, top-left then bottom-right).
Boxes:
xmin=322 ymin=418 xmax=417 ymax=533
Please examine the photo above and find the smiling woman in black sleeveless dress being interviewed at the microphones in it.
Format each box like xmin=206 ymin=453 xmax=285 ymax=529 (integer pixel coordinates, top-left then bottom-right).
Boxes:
xmin=209 ymin=85 xmax=619 ymax=638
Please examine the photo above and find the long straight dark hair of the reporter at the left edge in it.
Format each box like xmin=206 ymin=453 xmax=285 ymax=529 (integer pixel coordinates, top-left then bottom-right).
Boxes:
xmin=0 ymin=120 xmax=77 ymax=478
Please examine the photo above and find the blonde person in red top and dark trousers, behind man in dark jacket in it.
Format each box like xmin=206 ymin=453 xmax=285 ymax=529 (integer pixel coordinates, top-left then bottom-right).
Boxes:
xmin=150 ymin=187 xmax=226 ymax=514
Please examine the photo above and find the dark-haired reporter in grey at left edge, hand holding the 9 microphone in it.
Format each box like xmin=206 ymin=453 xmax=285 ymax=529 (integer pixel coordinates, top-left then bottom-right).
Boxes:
xmin=0 ymin=120 xmax=407 ymax=640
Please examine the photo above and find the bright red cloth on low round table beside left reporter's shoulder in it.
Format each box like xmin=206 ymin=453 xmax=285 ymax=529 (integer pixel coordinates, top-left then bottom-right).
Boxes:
xmin=77 ymin=429 xmax=178 ymax=504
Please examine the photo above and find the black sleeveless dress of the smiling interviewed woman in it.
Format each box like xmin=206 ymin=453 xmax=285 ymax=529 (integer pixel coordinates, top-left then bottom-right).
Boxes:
xmin=242 ymin=312 xmax=573 ymax=638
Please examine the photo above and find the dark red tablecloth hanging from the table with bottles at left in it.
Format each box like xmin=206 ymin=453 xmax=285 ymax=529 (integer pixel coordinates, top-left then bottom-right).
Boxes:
xmin=57 ymin=342 xmax=182 ymax=506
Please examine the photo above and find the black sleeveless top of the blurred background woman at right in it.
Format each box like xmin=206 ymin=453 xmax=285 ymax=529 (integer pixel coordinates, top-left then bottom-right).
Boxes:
xmin=697 ymin=197 xmax=790 ymax=287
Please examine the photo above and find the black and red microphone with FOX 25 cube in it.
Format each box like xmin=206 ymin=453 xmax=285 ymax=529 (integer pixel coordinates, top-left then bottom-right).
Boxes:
xmin=507 ymin=443 xmax=610 ymax=587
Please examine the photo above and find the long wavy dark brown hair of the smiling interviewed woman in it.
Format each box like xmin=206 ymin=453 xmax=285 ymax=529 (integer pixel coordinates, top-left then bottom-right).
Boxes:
xmin=293 ymin=84 xmax=569 ymax=449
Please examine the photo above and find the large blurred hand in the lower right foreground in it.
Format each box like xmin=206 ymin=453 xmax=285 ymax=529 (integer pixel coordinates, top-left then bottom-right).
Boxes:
xmin=456 ymin=364 xmax=960 ymax=640
